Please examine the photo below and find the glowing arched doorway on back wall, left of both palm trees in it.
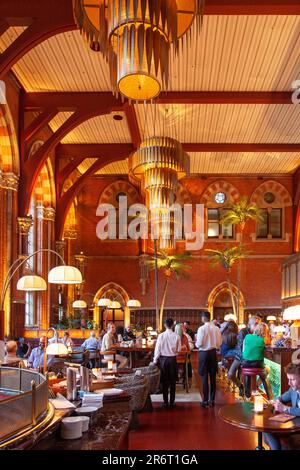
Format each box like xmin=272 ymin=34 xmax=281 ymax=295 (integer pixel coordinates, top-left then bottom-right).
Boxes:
xmin=94 ymin=282 xmax=130 ymax=330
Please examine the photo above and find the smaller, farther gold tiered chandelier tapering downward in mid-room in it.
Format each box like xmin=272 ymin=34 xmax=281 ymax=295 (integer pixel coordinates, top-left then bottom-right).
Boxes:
xmin=129 ymin=137 xmax=189 ymax=249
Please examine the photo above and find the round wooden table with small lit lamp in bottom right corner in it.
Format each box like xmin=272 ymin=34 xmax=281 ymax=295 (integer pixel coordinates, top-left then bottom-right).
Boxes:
xmin=219 ymin=403 xmax=300 ymax=450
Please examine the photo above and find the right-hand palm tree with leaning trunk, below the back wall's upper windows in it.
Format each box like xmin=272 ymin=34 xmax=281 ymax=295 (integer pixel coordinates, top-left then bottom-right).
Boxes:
xmin=205 ymin=245 xmax=248 ymax=318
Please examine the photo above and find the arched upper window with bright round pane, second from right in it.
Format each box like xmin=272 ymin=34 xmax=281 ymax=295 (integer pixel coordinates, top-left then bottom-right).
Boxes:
xmin=200 ymin=181 xmax=239 ymax=239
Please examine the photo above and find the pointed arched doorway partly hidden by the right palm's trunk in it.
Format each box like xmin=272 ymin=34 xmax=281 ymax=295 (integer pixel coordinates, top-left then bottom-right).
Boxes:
xmin=207 ymin=282 xmax=245 ymax=324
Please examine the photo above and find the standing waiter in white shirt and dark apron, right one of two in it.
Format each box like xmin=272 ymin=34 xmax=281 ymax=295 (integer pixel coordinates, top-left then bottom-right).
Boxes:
xmin=196 ymin=312 xmax=222 ymax=408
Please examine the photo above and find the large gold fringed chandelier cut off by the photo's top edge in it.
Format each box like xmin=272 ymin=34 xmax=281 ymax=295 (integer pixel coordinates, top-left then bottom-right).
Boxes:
xmin=73 ymin=0 xmax=204 ymax=101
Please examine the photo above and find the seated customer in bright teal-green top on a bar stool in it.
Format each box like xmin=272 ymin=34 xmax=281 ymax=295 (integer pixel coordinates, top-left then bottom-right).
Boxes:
xmin=242 ymin=323 xmax=269 ymax=398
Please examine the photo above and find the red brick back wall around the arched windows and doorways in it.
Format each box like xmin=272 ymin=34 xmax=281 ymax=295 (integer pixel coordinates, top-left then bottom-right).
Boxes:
xmin=71 ymin=177 xmax=293 ymax=308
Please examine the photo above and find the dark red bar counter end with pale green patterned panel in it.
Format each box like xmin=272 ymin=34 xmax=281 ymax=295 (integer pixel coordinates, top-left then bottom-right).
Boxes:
xmin=265 ymin=347 xmax=297 ymax=397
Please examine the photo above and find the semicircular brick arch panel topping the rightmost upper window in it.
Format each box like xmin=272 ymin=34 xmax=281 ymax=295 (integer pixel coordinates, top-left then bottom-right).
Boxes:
xmin=250 ymin=180 xmax=293 ymax=207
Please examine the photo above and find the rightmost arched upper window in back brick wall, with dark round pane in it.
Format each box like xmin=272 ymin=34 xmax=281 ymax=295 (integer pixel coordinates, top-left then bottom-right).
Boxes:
xmin=251 ymin=181 xmax=292 ymax=240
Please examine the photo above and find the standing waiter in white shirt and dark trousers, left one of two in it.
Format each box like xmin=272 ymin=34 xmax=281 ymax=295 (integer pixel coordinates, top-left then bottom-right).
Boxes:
xmin=153 ymin=318 xmax=181 ymax=408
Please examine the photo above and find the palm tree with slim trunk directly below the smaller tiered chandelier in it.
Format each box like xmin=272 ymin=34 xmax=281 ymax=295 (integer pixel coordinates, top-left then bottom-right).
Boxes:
xmin=147 ymin=250 xmax=192 ymax=331
